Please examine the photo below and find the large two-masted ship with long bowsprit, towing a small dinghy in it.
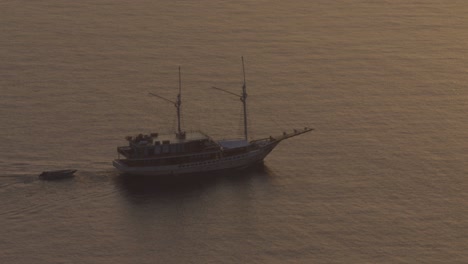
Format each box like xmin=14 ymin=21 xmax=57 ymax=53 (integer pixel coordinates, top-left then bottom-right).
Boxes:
xmin=113 ymin=57 xmax=314 ymax=176
